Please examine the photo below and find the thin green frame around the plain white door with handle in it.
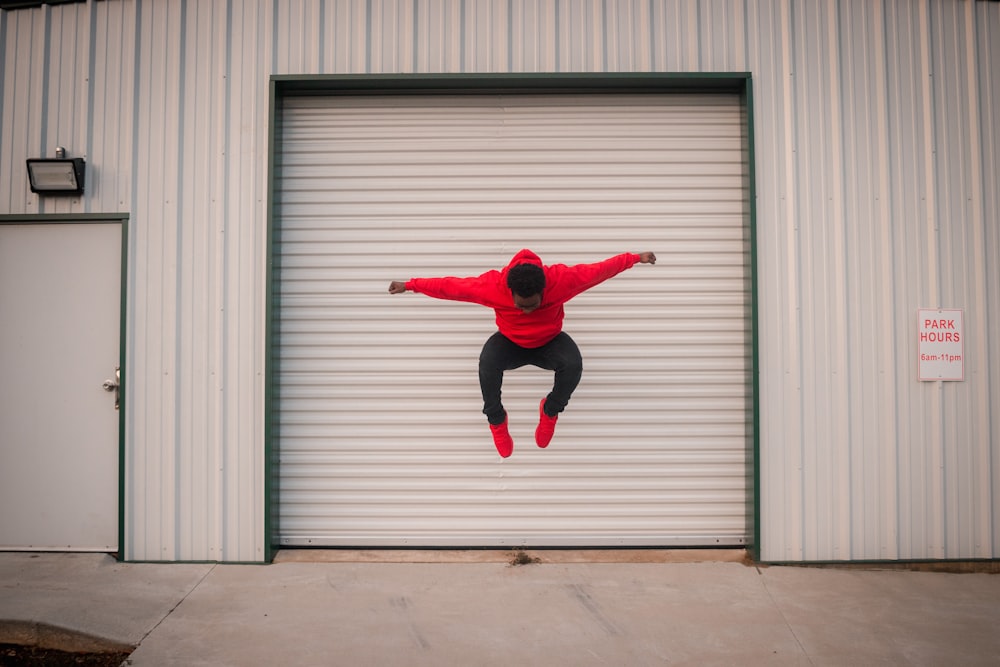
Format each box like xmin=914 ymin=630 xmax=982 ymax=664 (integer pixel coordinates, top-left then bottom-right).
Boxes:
xmin=0 ymin=213 xmax=129 ymax=561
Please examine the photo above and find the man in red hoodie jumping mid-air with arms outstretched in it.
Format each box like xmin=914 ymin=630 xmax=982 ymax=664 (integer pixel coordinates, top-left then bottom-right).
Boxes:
xmin=389 ymin=250 xmax=656 ymax=458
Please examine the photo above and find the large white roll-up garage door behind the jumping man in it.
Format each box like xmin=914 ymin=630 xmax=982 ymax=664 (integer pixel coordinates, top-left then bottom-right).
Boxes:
xmin=273 ymin=94 xmax=750 ymax=547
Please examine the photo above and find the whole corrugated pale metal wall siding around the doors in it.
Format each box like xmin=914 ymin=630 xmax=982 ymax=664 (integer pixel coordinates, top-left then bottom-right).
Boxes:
xmin=0 ymin=0 xmax=1000 ymax=560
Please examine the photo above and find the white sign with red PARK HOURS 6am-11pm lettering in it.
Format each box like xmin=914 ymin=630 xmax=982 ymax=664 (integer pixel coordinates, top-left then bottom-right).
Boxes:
xmin=917 ymin=308 xmax=965 ymax=382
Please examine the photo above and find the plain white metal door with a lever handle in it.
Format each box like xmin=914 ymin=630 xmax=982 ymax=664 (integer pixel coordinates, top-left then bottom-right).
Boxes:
xmin=0 ymin=222 xmax=122 ymax=552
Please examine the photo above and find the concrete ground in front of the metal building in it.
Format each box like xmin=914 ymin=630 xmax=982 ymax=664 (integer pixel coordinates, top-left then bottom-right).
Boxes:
xmin=0 ymin=551 xmax=1000 ymax=667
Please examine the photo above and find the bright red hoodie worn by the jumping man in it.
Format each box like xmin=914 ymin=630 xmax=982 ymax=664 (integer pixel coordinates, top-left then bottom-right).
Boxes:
xmin=406 ymin=250 xmax=639 ymax=348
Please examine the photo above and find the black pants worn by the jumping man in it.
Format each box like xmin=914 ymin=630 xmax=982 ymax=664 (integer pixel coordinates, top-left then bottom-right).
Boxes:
xmin=479 ymin=332 xmax=583 ymax=424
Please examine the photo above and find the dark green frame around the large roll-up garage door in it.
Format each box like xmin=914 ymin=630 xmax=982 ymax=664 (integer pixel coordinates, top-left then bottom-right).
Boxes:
xmin=264 ymin=72 xmax=760 ymax=562
